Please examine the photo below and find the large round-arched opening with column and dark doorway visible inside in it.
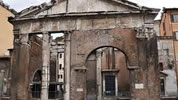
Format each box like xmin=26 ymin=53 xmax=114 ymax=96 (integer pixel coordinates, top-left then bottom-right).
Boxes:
xmin=86 ymin=47 xmax=130 ymax=100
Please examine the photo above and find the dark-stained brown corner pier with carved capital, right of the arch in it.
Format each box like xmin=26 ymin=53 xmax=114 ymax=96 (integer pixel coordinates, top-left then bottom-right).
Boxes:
xmin=132 ymin=26 xmax=160 ymax=100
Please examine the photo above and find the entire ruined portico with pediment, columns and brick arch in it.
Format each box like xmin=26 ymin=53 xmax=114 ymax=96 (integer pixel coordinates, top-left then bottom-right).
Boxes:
xmin=10 ymin=0 xmax=160 ymax=100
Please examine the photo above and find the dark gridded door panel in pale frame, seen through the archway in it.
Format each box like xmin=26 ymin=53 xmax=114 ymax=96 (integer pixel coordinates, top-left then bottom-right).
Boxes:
xmin=105 ymin=75 xmax=116 ymax=96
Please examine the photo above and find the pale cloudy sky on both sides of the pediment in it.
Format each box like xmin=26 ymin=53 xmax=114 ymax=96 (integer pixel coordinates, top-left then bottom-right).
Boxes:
xmin=3 ymin=0 xmax=178 ymax=11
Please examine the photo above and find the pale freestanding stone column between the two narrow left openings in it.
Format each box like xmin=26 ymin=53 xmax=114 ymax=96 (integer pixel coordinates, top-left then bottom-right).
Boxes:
xmin=41 ymin=32 xmax=50 ymax=100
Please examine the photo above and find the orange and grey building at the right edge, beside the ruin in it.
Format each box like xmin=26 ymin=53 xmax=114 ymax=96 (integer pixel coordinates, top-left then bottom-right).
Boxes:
xmin=158 ymin=8 xmax=178 ymax=97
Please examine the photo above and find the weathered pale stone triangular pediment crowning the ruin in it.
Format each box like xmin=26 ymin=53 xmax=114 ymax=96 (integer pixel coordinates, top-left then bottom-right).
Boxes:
xmin=18 ymin=0 xmax=156 ymax=17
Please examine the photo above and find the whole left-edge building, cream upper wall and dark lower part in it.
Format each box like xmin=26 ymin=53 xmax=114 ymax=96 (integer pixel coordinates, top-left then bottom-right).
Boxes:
xmin=0 ymin=1 xmax=15 ymax=99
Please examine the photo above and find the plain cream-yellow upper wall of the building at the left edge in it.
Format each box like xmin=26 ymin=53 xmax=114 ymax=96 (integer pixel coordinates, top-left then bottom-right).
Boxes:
xmin=0 ymin=1 xmax=14 ymax=57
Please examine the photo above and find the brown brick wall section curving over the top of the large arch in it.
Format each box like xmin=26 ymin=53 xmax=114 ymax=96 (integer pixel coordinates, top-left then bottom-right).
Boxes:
xmin=71 ymin=28 xmax=138 ymax=66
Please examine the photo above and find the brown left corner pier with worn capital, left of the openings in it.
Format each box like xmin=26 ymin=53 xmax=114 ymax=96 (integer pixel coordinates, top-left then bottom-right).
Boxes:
xmin=14 ymin=34 xmax=30 ymax=100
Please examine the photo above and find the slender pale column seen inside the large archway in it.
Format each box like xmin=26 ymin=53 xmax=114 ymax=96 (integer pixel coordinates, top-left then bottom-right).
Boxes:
xmin=96 ymin=50 xmax=102 ymax=100
